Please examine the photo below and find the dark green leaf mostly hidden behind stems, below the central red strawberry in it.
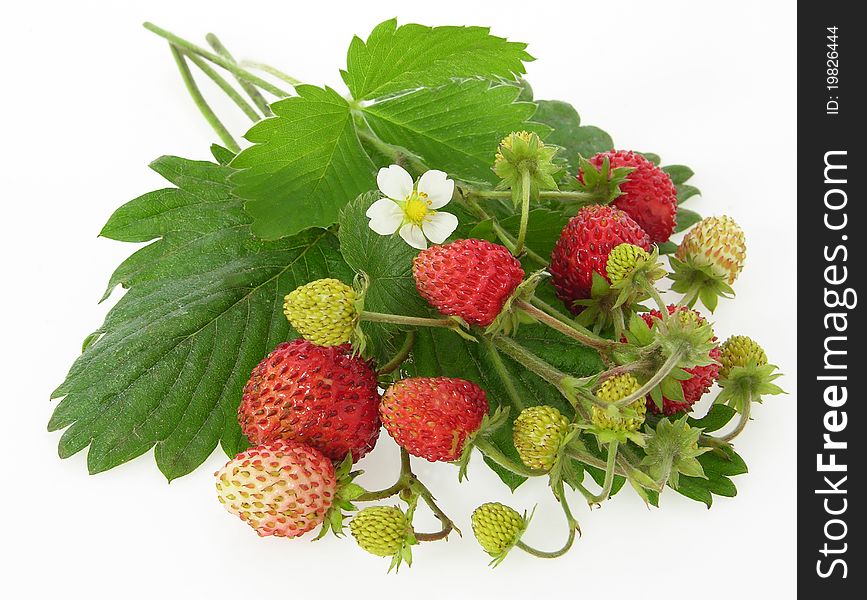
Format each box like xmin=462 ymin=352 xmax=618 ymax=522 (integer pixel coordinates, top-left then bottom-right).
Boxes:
xmin=409 ymin=325 xmax=604 ymax=489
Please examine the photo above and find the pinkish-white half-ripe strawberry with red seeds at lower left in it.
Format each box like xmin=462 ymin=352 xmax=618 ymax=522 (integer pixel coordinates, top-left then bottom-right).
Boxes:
xmin=215 ymin=440 xmax=337 ymax=537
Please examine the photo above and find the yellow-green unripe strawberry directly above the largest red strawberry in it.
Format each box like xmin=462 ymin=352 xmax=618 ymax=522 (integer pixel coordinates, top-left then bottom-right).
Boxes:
xmin=283 ymin=279 xmax=358 ymax=346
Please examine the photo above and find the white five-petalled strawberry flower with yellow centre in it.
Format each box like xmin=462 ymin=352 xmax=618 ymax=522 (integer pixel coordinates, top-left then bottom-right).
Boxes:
xmin=367 ymin=165 xmax=458 ymax=250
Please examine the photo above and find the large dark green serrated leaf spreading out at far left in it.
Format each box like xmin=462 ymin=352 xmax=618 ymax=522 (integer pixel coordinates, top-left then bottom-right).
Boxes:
xmin=48 ymin=157 xmax=352 ymax=480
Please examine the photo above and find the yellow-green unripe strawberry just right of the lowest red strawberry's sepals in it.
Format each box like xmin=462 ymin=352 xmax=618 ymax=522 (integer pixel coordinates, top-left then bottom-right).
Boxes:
xmin=512 ymin=406 xmax=569 ymax=471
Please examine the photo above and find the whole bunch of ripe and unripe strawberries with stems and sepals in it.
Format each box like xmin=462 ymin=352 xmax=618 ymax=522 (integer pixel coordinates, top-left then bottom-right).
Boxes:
xmin=216 ymin=139 xmax=780 ymax=566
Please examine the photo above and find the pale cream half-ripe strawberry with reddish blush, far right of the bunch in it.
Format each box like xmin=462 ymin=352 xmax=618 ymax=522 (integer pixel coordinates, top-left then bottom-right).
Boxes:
xmin=675 ymin=216 xmax=747 ymax=285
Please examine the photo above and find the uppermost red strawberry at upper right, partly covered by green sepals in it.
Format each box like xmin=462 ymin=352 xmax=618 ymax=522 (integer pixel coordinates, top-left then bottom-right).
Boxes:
xmin=578 ymin=150 xmax=677 ymax=244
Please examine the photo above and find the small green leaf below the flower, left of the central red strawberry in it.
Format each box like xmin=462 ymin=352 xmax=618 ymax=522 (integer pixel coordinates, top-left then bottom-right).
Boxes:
xmin=337 ymin=191 xmax=434 ymax=359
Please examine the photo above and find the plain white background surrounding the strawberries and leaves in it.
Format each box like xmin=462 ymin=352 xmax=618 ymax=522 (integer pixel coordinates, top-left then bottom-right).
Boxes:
xmin=0 ymin=0 xmax=796 ymax=600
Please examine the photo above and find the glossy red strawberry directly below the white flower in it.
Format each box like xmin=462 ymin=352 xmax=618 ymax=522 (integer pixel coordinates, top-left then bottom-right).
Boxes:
xmin=412 ymin=239 xmax=524 ymax=327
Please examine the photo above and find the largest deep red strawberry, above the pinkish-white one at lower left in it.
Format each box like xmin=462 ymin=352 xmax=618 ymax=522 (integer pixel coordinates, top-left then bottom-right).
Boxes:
xmin=238 ymin=338 xmax=379 ymax=460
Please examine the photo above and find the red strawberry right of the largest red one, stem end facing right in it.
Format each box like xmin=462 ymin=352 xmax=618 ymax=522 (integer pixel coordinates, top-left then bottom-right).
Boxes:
xmin=379 ymin=377 xmax=488 ymax=462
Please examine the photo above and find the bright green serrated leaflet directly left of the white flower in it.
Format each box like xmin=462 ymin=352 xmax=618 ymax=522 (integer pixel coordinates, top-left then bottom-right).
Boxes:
xmin=231 ymin=85 xmax=376 ymax=240
